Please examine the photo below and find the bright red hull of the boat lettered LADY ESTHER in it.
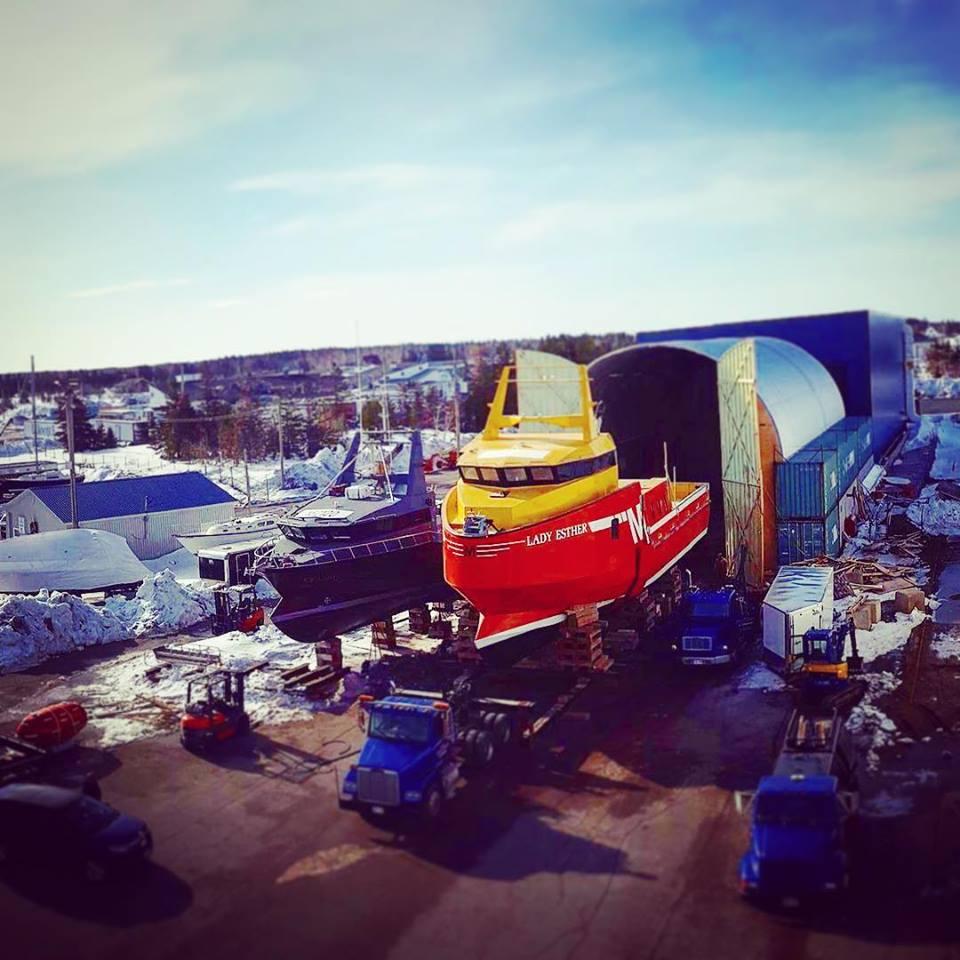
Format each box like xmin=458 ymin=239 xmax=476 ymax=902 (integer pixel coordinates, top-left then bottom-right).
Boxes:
xmin=443 ymin=480 xmax=710 ymax=648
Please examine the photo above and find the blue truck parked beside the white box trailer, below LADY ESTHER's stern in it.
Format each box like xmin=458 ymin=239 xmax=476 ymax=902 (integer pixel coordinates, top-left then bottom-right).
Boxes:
xmin=673 ymin=587 xmax=754 ymax=666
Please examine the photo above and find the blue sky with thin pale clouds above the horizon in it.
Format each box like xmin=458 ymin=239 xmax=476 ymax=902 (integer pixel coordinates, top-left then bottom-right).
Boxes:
xmin=0 ymin=0 xmax=960 ymax=371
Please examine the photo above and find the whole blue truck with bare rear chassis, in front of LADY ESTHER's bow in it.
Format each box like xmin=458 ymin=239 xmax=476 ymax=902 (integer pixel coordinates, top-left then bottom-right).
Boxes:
xmin=339 ymin=677 xmax=589 ymax=821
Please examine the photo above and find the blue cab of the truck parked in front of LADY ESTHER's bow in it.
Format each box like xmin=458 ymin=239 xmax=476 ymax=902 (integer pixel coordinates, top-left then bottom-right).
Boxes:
xmin=340 ymin=695 xmax=460 ymax=819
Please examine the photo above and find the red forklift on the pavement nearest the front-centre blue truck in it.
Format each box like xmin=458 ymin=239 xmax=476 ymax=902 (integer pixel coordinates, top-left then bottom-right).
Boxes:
xmin=180 ymin=660 xmax=266 ymax=753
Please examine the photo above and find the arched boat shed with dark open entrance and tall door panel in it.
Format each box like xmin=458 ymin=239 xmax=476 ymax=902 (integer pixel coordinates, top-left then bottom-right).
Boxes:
xmin=590 ymin=337 xmax=844 ymax=585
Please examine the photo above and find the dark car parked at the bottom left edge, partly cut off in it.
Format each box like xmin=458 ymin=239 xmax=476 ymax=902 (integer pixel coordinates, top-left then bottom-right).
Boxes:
xmin=0 ymin=783 xmax=153 ymax=880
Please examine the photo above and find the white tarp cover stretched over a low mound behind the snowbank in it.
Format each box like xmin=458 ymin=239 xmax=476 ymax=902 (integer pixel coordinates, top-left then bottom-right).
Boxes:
xmin=0 ymin=529 xmax=151 ymax=593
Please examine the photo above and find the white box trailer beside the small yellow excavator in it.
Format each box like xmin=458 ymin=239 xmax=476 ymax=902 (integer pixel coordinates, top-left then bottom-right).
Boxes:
xmin=761 ymin=566 xmax=833 ymax=669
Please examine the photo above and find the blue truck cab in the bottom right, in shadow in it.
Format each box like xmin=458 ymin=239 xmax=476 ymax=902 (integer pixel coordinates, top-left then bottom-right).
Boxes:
xmin=740 ymin=774 xmax=849 ymax=900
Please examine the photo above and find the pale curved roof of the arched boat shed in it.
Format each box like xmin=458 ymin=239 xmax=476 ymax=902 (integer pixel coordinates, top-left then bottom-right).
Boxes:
xmin=637 ymin=337 xmax=846 ymax=459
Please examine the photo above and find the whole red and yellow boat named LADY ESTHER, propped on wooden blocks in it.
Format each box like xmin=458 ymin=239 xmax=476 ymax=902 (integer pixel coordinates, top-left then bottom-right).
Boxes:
xmin=443 ymin=366 xmax=710 ymax=649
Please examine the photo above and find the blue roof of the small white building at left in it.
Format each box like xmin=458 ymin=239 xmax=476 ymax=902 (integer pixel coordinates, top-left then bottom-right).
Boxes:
xmin=34 ymin=470 xmax=235 ymax=522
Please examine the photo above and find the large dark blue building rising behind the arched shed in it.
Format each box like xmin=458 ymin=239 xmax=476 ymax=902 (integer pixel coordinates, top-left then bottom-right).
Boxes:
xmin=637 ymin=310 xmax=912 ymax=454
